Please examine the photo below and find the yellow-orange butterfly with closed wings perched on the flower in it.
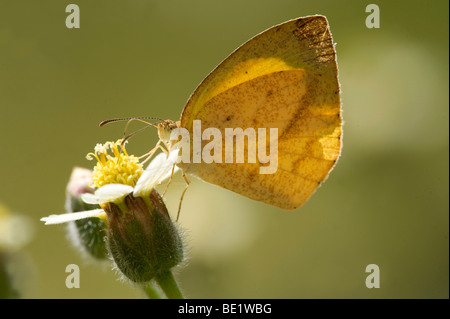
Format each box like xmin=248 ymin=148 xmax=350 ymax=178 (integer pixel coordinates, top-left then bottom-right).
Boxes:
xmin=115 ymin=15 xmax=342 ymax=215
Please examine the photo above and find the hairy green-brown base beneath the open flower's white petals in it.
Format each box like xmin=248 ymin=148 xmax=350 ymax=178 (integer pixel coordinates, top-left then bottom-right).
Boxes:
xmin=103 ymin=189 xmax=183 ymax=283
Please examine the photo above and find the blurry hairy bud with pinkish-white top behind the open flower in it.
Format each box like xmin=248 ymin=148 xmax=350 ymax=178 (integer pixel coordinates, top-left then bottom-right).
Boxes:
xmin=66 ymin=167 xmax=107 ymax=260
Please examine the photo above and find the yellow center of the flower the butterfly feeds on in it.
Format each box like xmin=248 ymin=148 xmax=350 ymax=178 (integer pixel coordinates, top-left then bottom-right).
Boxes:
xmin=86 ymin=140 xmax=143 ymax=188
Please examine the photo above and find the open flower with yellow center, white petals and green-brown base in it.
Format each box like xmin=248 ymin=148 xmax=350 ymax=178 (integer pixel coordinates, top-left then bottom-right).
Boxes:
xmin=41 ymin=141 xmax=183 ymax=283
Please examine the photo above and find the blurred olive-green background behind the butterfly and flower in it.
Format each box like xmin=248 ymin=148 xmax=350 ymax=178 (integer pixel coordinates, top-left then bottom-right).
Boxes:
xmin=0 ymin=0 xmax=449 ymax=298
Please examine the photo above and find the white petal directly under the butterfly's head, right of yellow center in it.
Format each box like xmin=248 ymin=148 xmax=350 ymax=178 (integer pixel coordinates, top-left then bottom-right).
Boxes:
xmin=133 ymin=149 xmax=179 ymax=197
